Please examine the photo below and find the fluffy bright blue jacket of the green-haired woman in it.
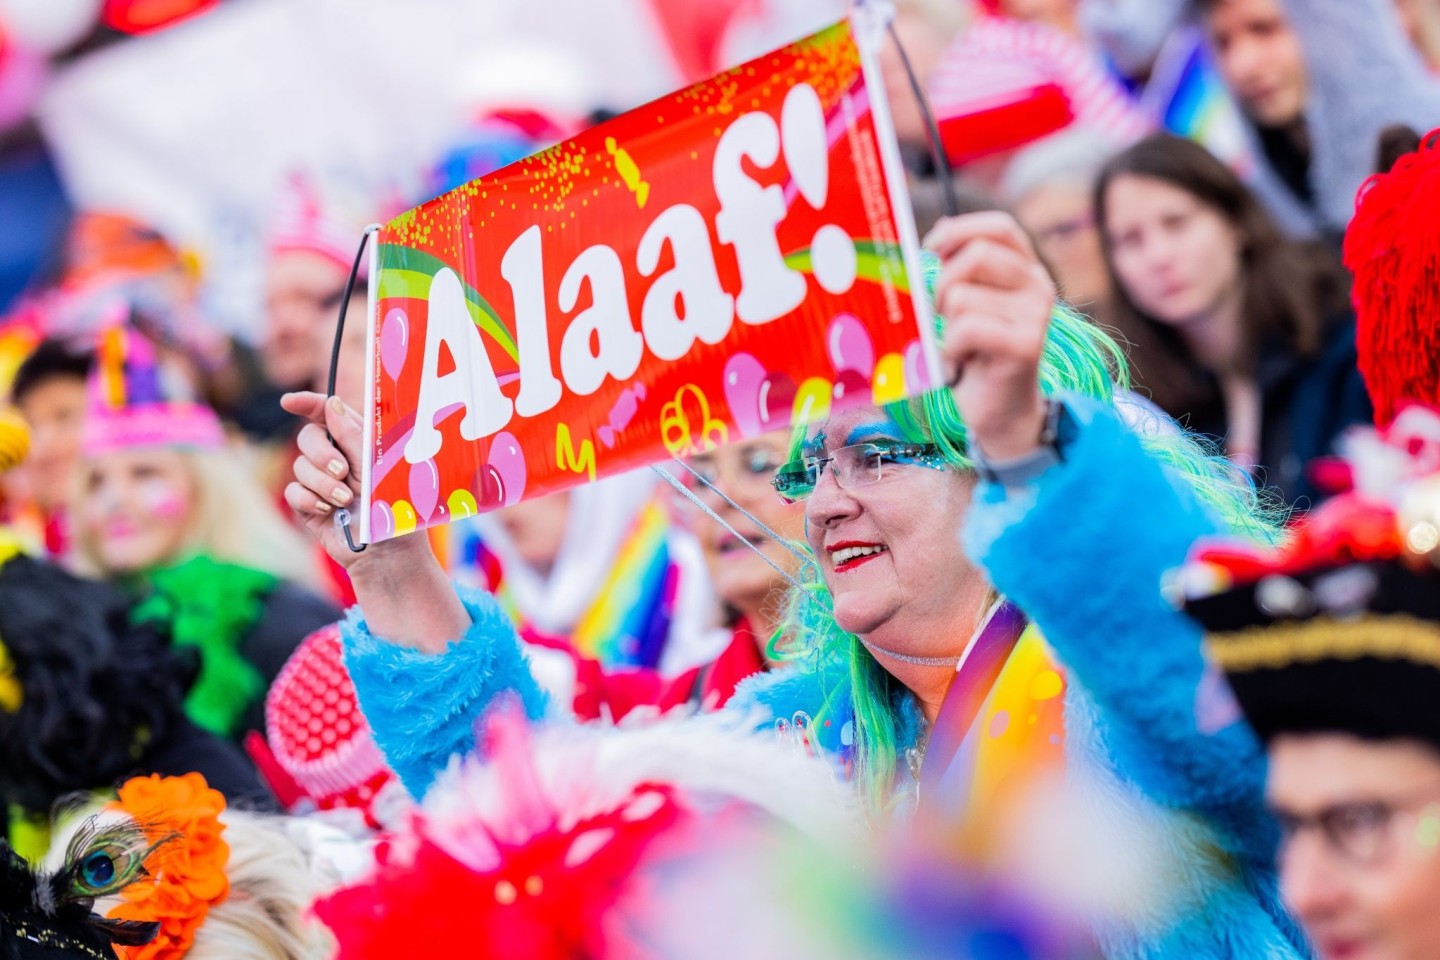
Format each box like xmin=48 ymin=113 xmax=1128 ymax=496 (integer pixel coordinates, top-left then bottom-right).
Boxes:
xmin=344 ymin=397 xmax=1306 ymax=960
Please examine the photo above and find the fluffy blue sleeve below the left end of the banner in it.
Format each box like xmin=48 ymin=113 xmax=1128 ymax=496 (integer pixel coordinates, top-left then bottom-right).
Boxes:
xmin=341 ymin=587 xmax=546 ymax=797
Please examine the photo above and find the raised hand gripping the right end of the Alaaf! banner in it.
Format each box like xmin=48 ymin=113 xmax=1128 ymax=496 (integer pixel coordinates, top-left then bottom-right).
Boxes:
xmin=924 ymin=212 xmax=1056 ymax=461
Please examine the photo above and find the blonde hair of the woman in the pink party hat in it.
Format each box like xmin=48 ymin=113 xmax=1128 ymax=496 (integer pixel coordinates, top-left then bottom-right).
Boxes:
xmin=71 ymin=448 xmax=320 ymax=587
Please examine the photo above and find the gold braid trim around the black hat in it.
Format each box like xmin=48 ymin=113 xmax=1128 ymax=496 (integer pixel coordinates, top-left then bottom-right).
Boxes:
xmin=1208 ymin=613 xmax=1440 ymax=674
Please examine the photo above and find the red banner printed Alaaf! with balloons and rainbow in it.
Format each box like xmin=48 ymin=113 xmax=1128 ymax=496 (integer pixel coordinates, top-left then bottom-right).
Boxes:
xmin=360 ymin=6 xmax=939 ymax=543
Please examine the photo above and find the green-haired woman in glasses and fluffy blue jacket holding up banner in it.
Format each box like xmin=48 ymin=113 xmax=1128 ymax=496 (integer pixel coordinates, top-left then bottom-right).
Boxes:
xmin=287 ymin=213 xmax=1305 ymax=957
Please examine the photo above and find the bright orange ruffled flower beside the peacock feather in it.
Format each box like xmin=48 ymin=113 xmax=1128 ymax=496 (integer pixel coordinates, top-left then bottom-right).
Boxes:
xmin=109 ymin=773 xmax=230 ymax=960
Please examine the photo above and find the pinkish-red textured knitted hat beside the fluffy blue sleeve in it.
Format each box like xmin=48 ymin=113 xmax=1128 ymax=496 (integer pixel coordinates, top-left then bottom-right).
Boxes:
xmin=265 ymin=623 xmax=406 ymax=828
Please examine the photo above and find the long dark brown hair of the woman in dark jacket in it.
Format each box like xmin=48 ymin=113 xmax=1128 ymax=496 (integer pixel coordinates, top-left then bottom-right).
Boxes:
xmin=1094 ymin=134 xmax=1349 ymax=416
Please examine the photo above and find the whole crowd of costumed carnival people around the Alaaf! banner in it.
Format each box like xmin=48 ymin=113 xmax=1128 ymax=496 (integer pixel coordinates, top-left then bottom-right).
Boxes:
xmin=0 ymin=0 xmax=1440 ymax=960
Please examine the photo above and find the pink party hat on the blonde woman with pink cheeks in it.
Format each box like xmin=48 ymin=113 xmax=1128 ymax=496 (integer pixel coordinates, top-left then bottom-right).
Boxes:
xmin=81 ymin=324 xmax=225 ymax=456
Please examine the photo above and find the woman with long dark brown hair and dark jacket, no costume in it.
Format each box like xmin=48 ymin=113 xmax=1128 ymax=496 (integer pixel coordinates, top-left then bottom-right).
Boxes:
xmin=1096 ymin=135 xmax=1371 ymax=510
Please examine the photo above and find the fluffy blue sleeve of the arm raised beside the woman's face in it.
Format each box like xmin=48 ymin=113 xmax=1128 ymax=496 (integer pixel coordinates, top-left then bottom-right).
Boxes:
xmin=965 ymin=397 xmax=1269 ymax=849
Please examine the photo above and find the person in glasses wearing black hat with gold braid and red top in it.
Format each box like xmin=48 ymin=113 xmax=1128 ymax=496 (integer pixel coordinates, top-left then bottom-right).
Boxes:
xmin=1181 ymin=417 xmax=1440 ymax=960
